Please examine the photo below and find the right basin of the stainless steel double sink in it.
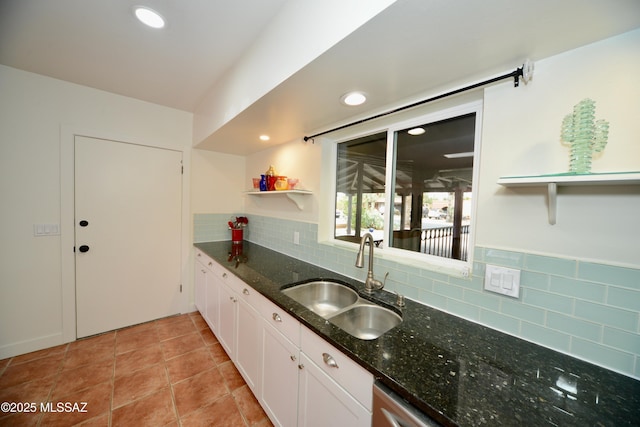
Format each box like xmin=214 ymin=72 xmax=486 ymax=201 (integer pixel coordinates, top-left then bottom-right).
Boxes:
xmin=329 ymin=304 xmax=402 ymax=340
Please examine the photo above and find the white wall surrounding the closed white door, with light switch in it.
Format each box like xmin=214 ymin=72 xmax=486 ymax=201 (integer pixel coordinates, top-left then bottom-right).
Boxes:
xmin=0 ymin=66 xmax=193 ymax=359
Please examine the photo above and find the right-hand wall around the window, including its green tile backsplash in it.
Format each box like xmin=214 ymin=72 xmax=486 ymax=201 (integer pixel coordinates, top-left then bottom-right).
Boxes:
xmin=241 ymin=30 xmax=640 ymax=378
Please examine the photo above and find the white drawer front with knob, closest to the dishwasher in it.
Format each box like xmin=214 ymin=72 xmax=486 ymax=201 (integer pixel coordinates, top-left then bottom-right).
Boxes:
xmin=300 ymin=327 xmax=373 ymax=411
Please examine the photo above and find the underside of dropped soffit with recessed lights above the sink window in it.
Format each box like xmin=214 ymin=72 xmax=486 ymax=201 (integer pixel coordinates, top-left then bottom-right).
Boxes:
xmin=197 ymin=0 xmax=640 ymax=155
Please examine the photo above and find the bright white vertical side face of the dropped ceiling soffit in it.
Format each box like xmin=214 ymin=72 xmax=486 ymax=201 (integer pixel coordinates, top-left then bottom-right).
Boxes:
xmin=193 ymin=0 xmax=396 ymax=145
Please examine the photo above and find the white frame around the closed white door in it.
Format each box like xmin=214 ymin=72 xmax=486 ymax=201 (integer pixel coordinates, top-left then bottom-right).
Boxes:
xmin=60 ymin=125 xmax=192 ymax=343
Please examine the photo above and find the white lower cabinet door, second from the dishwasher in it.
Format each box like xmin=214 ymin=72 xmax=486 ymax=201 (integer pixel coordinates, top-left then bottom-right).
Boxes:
xmin=258 ymin=320 xmax=300 ymax=427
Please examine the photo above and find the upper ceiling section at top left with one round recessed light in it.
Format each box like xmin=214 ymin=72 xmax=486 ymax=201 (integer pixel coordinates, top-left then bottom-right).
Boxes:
xmin=0 ymin=0 xmax=287 ymax=112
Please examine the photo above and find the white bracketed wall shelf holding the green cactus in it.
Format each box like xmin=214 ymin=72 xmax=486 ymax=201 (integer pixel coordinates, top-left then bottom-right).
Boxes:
xmin=498 ymin=172 xmax=640 ymax=225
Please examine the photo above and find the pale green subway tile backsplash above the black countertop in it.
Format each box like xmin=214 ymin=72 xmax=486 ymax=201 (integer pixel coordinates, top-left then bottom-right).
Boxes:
xmin=194 ymin=214 xmax=640 ymax=378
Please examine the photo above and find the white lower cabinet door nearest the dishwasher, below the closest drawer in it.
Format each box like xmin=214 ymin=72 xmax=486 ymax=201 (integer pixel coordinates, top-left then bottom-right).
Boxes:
xmin=298 ymin=353 xmax=371 ymax=427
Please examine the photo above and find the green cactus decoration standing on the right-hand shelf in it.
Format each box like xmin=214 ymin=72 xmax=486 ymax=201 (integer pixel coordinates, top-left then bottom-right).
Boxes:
xmin=561 ymin=98 xmax=609 ymax=174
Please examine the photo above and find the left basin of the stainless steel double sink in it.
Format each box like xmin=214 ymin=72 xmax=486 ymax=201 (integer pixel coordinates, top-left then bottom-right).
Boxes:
xmin=282 ymin=280 xmax=358 ymax=319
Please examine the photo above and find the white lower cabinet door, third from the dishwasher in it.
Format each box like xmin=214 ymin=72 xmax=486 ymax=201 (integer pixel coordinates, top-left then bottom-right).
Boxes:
xmin=234 ymin=299 xmax=263 ymax=394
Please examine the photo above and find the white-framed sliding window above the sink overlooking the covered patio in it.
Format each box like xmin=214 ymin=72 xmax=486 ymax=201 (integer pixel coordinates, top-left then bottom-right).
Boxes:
xmin=333 ymin=104 xmax=480 ymax=270
